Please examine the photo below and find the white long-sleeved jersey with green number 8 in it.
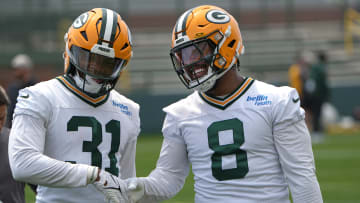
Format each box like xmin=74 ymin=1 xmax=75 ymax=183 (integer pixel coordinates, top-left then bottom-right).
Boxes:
xmin=143 ymin=78 xmax=322 ymax=203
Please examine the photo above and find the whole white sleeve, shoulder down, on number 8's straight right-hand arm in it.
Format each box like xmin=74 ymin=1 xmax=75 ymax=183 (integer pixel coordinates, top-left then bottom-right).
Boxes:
xmin=273 ymin=88 xmax=322 ymax=203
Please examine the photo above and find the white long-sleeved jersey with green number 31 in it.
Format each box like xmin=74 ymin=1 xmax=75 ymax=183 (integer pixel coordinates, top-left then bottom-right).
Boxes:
xmin=9 ymin=76 xmax=140 ymax=203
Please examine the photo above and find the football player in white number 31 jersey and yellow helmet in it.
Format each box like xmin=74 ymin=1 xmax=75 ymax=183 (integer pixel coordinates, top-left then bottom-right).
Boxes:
xmin=9 ymin=8 xmax=140 ymax=203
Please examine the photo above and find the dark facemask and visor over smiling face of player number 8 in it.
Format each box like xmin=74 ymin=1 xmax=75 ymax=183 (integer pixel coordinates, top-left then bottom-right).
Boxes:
xmin=170 ymin=31 xmax=226 ymax=92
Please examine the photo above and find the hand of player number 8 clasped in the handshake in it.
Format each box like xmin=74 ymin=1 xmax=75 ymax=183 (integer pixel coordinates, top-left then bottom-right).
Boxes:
xmin=125 ymin=178 xmax=145 ymax=203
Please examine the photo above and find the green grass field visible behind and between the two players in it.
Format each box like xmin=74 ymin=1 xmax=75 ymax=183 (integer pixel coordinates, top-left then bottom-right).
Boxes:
xmin=26 ymin=134 xmax=360 ymax=203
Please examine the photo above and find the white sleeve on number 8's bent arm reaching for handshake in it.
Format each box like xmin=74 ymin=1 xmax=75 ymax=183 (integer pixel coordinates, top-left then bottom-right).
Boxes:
xmin=136 ymin=114 xmax=189 ymax=202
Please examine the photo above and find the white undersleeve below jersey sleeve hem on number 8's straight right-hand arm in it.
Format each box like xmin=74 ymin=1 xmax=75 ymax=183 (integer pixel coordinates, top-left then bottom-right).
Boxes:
xmin=275 ymin=120 xmax=323 ymax=203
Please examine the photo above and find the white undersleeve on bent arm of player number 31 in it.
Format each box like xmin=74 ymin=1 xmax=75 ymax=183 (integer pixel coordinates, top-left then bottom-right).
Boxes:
xmin=9 ymin=114 xmax=90 ymax=187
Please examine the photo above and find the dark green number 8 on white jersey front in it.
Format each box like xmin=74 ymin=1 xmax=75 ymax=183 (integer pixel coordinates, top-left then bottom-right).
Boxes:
xmin=207 ymin=118 xmax=249 ymax=181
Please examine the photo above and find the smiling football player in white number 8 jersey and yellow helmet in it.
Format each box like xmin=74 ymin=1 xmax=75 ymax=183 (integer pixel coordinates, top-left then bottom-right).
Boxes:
xmin=128 ymin=5 xmax=322 ymax=203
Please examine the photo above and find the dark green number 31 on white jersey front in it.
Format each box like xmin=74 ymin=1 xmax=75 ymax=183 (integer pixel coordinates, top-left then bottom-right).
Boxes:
xmin=67 ymin=116 xmax=120 ymax=176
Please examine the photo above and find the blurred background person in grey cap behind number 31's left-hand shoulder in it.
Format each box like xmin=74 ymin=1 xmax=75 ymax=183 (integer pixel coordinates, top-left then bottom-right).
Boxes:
xmin=6 ymin=54 xmax=36 ymax=128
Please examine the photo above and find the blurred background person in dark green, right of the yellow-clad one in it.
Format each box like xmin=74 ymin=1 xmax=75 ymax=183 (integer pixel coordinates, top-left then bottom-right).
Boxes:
xmin=303 ymin=51 xmax=330 ymax=143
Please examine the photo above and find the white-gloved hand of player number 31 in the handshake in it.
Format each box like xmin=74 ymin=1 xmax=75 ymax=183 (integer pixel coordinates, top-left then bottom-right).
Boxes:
xmin=93 ymin=169 xmax=129 ymax=203
